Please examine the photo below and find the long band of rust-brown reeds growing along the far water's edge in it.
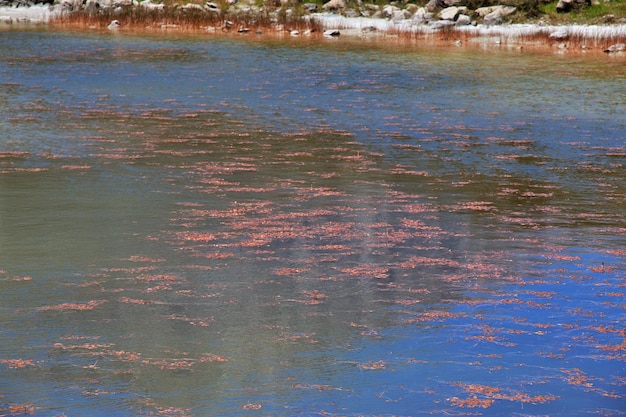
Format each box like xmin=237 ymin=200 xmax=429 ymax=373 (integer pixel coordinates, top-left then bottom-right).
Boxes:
xmin=51 ymin=4 xmax=626 ymax=49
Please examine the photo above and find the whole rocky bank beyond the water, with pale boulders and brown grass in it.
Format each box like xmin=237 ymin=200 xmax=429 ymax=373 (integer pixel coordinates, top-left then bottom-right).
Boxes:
xmin=0 ymin=0 xmax=626 ymax=53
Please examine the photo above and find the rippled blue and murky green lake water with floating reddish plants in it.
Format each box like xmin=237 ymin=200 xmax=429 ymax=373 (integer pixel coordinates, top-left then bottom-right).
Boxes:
xmin=0 ymin=29 xmax=626 ymax=417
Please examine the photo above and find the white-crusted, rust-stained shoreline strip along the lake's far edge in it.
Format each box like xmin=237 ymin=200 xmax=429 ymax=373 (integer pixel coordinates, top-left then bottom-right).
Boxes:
xmin=0 ymin=4 xmax=626 ymax=56
